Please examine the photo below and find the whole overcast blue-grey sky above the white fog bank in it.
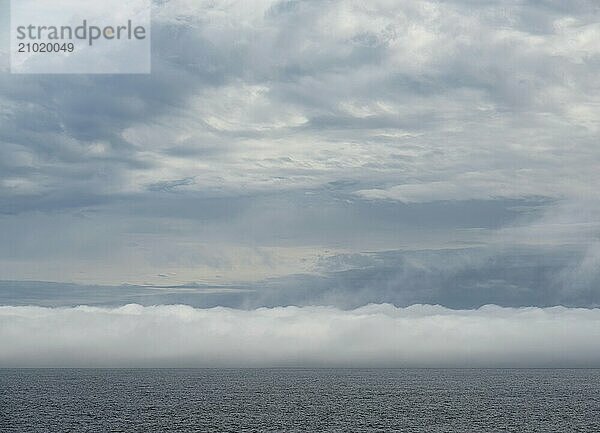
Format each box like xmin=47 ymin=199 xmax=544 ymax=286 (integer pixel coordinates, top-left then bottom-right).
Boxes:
xmin=0 ymin=0 xmax=600 ymax=364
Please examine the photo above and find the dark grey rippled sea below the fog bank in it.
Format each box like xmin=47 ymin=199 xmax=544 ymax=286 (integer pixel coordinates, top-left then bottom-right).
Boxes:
xmin=0 ymin=369 xmax=600 ymax=433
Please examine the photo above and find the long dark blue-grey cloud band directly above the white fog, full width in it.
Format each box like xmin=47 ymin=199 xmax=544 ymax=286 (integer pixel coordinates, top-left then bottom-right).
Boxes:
xmin=0 ymin=241 xmax=600 ymax=309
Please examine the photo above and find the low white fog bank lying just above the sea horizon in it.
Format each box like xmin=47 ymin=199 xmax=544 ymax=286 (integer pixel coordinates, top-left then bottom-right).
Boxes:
xmin=0 ymin=304 xmax=600 ymax=367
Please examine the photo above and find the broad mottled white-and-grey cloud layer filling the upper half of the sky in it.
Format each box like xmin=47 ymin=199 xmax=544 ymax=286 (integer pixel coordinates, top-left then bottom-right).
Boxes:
xmin=0 ymin=0 xmax=600 ymax=212
